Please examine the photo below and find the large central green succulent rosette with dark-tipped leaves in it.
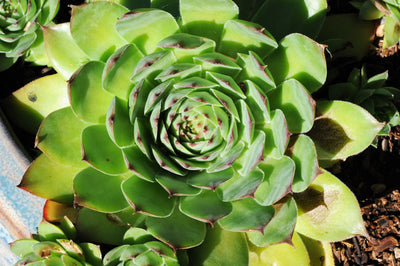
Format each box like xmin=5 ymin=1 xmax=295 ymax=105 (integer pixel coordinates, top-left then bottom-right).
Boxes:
xmin=6 ymin=0 xmax=383 ymax=265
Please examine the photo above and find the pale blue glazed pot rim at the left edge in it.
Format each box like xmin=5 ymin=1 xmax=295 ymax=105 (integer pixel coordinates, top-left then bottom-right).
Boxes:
xmin=0 ymin=109 xmax=44 ymax=266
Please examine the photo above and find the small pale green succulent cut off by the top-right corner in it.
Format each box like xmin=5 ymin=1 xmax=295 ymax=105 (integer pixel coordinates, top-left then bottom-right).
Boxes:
xmin=350 ymin=0 xmax=400 ymax=49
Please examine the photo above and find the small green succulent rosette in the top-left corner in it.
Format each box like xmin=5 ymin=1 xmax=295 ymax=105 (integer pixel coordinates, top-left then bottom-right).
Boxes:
xmin=0 ymin=0 xmax=59 ymax=70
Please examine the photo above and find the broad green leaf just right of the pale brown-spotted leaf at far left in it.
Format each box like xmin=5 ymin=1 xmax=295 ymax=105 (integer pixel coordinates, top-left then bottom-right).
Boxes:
xmin=69 ymin=61 xmax=113 ymax=123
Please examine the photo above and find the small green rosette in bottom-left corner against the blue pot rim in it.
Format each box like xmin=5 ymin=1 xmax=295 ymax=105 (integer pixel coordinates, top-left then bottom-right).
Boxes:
xmin=10 ymin=218 xmax=102 ymax=266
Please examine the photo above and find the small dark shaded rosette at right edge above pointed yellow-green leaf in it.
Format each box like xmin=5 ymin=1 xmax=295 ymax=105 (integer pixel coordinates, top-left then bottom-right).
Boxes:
xmin=329 ymin=67 xmax=400 ymax=135
